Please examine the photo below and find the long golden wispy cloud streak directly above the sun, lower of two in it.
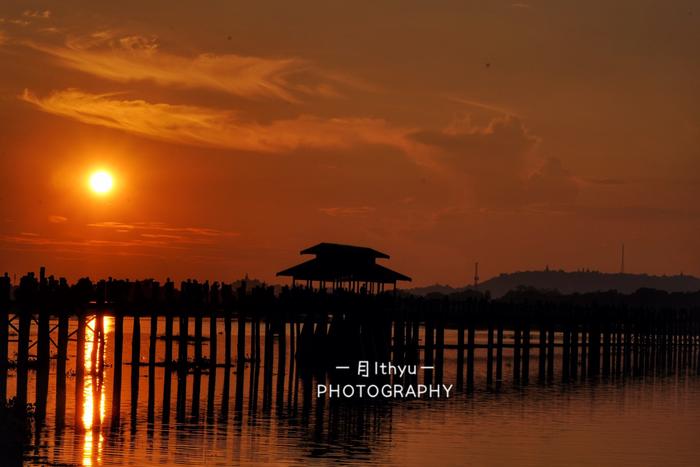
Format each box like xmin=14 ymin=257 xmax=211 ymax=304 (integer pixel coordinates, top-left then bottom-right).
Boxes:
xmin=20 ymin=89 xmax=412 ymax=152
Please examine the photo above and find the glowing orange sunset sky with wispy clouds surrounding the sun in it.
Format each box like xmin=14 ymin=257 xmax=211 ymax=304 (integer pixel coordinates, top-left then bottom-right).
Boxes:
xmin=0 ymin=0 xmax=700 ymax=285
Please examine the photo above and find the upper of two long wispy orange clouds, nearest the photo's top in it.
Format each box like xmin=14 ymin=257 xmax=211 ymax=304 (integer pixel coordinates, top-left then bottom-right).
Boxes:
xmin=20 ymin=30 xmax=354 ymax=102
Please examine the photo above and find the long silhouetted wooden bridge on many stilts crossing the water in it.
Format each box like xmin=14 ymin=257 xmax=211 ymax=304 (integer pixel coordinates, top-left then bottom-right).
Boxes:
xmin=0 ymin=275 xmax=700 ymax=436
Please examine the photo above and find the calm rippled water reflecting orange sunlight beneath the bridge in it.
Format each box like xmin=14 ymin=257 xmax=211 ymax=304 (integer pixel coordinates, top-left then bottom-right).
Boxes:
xmin=8 ymin=318 xmax=700 ymax=466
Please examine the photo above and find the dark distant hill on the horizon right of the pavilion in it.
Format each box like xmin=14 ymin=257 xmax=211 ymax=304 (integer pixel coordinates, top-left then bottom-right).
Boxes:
xmin=406 ymin=270 xmax=700 ymax=298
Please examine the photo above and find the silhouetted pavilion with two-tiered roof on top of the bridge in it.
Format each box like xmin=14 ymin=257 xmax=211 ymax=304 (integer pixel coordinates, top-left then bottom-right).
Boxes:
xmin=277 ymin=243 xmax=411 ymax=293
